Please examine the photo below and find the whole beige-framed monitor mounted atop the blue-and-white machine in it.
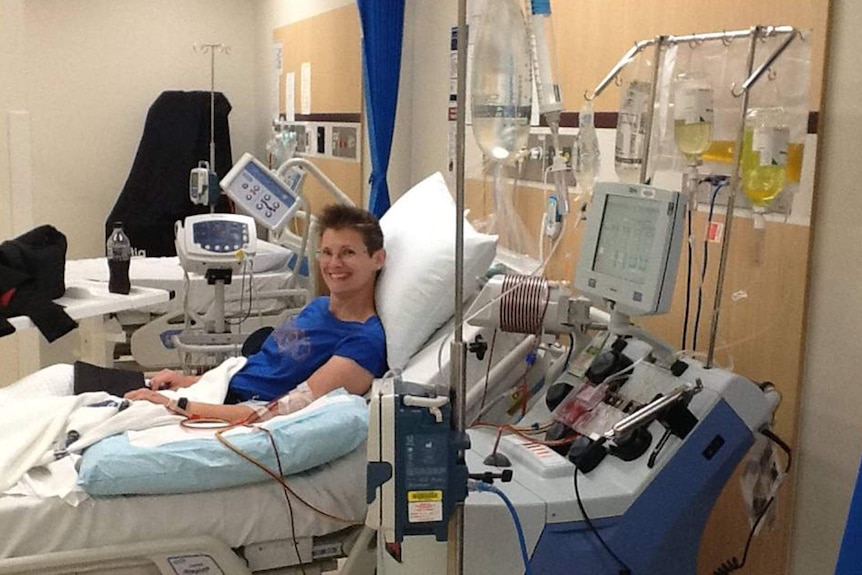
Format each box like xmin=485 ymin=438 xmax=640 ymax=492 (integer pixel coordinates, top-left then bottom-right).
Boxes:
xmin=575 ymin=182 xmax=686 ymax=315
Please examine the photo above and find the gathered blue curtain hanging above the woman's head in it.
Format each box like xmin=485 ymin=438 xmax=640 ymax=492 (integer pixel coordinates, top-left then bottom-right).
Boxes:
xmin=356 ymin=0 xmax=405 ymax=217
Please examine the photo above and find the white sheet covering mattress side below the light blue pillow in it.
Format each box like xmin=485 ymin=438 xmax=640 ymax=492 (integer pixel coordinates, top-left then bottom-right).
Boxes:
xmin=0 ymin=443 xmax=366 ymax=558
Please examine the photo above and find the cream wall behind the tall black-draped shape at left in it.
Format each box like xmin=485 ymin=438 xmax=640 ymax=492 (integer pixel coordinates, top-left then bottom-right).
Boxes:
xmin=0 ymin=0 xmax=262 ymax=385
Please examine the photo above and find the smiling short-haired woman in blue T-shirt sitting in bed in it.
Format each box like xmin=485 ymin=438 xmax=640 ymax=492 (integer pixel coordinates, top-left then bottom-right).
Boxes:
xmin=125 ymin=205 xmax=386 ymax=422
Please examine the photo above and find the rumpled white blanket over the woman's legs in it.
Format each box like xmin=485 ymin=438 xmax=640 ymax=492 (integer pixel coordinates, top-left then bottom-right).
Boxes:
xmin=0 ymin=358 xmax=245 ymax=503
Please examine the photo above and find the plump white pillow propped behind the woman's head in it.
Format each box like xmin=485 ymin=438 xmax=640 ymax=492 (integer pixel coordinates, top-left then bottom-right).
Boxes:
xmin=376 ymin=172 xmax=497 ymax=368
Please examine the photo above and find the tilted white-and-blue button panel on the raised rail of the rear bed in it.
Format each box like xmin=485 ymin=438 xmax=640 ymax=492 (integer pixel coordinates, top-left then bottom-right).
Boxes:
xmin=221 ymin=153 xmax=305 ymax=231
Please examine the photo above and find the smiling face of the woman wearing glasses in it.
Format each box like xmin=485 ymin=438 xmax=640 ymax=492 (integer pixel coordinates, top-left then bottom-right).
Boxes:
xmin=317 ymin=228 xmax=385 ymax=297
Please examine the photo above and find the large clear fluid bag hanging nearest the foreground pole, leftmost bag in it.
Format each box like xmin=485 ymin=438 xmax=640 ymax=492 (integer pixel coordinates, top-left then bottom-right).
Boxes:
xmin=470 ymin=0 xmax=533 ymax=162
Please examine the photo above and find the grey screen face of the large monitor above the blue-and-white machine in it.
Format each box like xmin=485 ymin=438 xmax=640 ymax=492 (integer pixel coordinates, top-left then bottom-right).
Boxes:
xmin=593 ymin=195 xmax=660 ymax=285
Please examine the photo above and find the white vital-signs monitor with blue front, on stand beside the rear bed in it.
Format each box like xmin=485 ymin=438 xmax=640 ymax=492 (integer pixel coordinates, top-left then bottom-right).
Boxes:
xmin=174 ymin=214 xmax=257 ymax=274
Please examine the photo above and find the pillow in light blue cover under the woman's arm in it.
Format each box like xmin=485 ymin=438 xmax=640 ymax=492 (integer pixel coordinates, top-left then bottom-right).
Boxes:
xmin=78 ymin=390 xmax=368 ymax=495
